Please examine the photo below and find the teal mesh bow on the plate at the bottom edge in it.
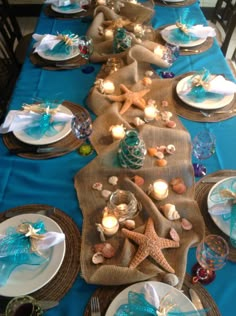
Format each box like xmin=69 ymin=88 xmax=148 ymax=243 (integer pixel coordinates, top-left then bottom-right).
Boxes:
xmin=115 ymin=291 xmax=207 ymax=316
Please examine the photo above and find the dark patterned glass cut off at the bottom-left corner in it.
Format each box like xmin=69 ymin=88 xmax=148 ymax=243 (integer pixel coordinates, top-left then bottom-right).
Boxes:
xmin=5 ymin=295 xmax=43 ymax=316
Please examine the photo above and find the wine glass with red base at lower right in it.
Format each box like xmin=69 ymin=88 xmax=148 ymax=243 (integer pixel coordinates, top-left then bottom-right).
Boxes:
xmin=192 ymin=235 xmax=229 ymax=284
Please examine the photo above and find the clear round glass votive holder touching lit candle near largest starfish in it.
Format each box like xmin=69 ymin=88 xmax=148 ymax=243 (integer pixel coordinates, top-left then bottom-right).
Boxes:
xmin=108 ymin=189 xmax=139 ymax=222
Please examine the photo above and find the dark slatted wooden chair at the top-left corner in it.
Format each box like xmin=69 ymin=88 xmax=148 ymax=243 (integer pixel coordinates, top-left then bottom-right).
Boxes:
xmin=0 ymin=0 xmax=32 ymax=65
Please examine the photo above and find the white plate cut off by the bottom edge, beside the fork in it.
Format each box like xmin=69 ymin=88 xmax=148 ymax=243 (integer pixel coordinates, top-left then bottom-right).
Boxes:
xmin=105 ymin=281 xmax=197 ymax=316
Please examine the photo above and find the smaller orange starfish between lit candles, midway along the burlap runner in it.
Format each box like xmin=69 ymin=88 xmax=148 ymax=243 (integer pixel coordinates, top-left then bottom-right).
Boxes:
xmin=107 ymin=84 xmax=150 ymax=114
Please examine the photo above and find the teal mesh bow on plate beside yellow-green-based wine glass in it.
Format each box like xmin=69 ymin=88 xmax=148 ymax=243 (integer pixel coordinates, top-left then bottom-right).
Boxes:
xmin=24 ymin=102 xmax=65 ymax=139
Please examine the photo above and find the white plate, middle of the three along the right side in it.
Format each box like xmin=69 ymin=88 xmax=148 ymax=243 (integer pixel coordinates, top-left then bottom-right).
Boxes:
xmin=176 ymin=75 xmax=234 ymax=110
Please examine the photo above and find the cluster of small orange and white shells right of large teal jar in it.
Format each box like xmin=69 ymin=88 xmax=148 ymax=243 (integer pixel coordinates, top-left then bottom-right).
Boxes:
xmin=147 ymin=144 xmax=176 ymax=167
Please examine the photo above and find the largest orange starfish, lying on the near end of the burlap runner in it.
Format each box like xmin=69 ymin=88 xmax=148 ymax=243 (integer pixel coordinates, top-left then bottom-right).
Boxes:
xmin=122 ymin=217 xmax=179 ymax=273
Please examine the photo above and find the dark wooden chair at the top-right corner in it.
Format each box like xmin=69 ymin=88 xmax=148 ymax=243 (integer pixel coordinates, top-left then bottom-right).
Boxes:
xmin=210 ymin=0 xmax=236 ymax=55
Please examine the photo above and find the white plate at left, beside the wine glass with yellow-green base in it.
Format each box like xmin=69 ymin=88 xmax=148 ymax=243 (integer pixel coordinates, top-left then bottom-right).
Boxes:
xmin=13 ymin=105 xmax=73 ymax=145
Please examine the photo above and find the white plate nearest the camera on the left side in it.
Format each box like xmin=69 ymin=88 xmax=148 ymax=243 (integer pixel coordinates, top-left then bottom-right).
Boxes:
xmin=0 ymin=214 xmax=66 ymax=297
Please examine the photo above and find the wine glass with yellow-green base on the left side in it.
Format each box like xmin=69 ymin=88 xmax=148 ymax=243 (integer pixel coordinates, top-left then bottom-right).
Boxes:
xmin=71 ymin=110 xmax=93 ymax=156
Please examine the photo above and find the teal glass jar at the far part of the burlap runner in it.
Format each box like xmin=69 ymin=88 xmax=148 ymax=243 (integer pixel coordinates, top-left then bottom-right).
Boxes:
xmin=113 ymin=27 xmax=132 ymax=54
